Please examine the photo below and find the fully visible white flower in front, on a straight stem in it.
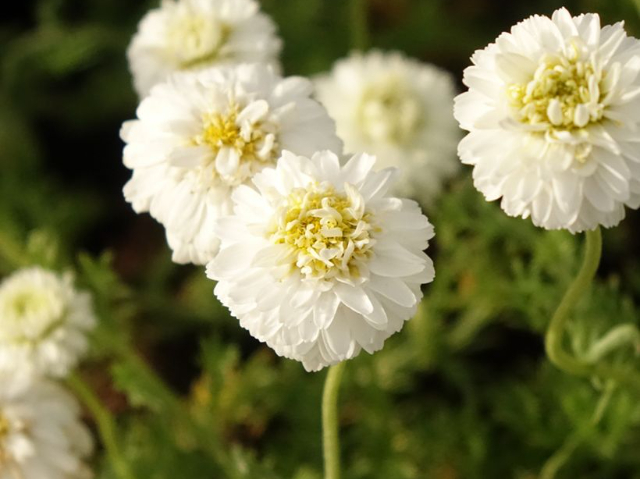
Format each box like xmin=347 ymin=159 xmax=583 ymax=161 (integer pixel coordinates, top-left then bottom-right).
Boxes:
xmin=207 ymin=151 xmax=434 ymax=371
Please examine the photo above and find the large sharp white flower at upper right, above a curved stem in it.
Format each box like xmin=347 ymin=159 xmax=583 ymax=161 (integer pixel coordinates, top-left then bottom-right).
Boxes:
xmin=455 ymin=8 xmax=640 ymax=233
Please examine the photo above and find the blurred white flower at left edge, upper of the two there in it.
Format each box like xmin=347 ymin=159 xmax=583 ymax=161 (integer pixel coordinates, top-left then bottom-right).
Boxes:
xmin=0 ymin=267 xmax=96 ymax=377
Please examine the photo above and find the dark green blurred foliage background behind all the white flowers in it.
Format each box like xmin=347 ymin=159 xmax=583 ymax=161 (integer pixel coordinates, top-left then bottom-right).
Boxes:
xmin=0 ymin=0 xmax=640 ymax=479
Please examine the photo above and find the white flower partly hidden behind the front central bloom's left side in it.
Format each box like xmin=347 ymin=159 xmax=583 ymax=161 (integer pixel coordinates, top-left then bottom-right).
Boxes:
xmin=122 ymin=64 xmax=342 ymax=264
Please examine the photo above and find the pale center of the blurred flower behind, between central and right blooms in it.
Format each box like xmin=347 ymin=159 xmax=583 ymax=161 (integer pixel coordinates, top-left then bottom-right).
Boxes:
xmin=357 ymin=77 xmax=424 ymax=145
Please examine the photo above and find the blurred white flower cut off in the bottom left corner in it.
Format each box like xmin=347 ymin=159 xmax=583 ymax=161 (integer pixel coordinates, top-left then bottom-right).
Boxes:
xmin=0 ymin=374 xmax=93 ymax=479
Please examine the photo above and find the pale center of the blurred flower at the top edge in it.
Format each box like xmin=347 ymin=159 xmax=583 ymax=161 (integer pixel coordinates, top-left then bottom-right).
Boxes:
xmin=166 ymin=12 xmax=229 ymax=69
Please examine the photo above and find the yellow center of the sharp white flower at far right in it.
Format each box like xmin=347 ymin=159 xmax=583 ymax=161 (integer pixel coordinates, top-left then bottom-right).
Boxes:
xmin=507 ymin=55 xmax=604 ymax=131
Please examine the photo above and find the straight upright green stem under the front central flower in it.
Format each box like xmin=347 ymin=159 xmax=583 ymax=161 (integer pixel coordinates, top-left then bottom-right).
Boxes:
xmin=322 ymin=361 xmax=345 ymax=479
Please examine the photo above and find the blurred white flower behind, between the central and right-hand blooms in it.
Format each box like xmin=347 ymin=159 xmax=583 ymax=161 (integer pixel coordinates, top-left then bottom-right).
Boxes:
xmin=316 ymin=51 xmax=460 ymax=204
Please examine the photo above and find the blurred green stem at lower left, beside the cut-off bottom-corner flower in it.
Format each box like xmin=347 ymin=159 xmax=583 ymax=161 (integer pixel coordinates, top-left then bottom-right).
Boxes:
xmin=67 ymin=374 xmax=135 ymax=479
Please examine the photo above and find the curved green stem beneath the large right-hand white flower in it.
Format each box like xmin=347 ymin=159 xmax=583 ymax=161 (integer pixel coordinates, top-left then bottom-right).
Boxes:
xmin=545 ymin=227 xmax=602 ymax=376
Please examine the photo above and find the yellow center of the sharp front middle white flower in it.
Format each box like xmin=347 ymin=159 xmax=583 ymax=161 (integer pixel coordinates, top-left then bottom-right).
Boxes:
xmin=271 ymin=183 xmax=375 ymax=280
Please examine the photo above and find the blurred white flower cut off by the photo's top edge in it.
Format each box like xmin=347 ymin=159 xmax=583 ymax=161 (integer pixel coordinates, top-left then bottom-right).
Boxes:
xmin=127 ymin=0 xmax=282 ymax=97
